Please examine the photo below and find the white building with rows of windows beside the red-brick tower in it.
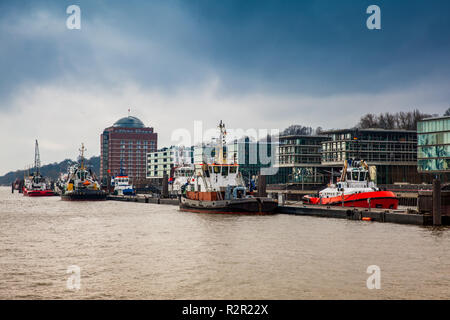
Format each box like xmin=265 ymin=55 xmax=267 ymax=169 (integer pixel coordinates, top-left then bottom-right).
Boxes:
xmin=147 ymin=146 xmax=194 ymax=179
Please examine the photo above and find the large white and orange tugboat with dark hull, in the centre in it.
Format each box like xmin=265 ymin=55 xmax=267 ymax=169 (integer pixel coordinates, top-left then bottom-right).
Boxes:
xmin=179 ymin=121 xmax=278 ymax=214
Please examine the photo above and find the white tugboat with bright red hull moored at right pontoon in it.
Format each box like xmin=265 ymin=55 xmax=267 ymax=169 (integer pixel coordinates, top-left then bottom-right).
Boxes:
xmin=303 ymin=160 xmax=398 ymax=209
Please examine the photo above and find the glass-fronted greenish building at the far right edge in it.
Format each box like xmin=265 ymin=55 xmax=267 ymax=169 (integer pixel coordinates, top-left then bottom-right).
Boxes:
xmin=417 ymin=117 xmax=450 ymax=173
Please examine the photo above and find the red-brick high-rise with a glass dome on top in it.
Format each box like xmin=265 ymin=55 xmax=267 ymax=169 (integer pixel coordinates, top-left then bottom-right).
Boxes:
xmin=100 ymin=116 xmax=158 ymax=184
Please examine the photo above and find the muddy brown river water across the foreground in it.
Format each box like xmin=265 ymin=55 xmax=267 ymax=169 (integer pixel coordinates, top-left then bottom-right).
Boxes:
xmin=0 ymin=188 xmax=450 ymax=299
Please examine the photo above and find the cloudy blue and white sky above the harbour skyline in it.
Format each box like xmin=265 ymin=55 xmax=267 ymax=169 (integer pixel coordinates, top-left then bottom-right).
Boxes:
xmin=0 ymin=0 xmax=450 ymax=175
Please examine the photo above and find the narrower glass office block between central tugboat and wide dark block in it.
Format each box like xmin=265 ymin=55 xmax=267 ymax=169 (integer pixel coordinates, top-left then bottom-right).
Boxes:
xmin=269 ymin=135 xmax=331 ymax=187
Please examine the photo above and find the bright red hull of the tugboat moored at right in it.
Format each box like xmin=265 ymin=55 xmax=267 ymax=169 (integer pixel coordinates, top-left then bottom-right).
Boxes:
xmin=303 ymin=191 xmax=398 ymax=209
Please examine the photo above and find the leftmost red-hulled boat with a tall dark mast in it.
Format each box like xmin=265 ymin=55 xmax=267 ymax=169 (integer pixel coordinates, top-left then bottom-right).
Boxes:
xmin=22 ymin=140 xmax=55 ymax=197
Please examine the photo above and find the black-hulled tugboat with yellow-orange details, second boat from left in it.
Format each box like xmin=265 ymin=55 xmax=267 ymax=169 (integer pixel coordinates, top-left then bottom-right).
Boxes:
xmin=61 ymin=144 xmax=106 ymax=201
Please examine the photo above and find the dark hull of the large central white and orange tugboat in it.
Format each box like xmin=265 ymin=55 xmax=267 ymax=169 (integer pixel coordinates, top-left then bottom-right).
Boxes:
xmin=180 ymin=196 xmax=278 ymax=214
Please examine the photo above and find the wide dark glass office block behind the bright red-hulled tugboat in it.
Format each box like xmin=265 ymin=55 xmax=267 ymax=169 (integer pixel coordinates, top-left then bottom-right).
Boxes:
xmin=322 ymin=128 xmax=422 ymax=184
